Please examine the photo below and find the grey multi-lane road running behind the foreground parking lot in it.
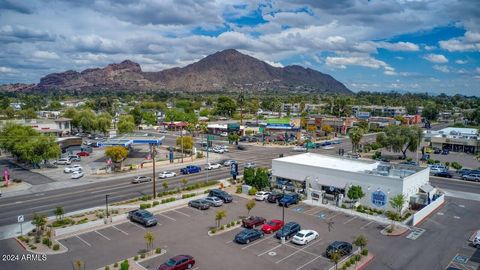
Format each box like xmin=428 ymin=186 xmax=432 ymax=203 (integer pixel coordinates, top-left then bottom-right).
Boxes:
xmin=0 ymin=132 xmax=480 ymax=229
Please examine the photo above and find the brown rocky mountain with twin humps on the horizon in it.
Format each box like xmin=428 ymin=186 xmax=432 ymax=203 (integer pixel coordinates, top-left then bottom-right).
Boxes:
xmin=1 ymin=49 xmax=351 ymax=94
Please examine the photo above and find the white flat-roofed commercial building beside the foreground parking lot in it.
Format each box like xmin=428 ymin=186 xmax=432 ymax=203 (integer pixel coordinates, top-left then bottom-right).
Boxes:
xmin=272 ymin=153 xmax=437 ymax=213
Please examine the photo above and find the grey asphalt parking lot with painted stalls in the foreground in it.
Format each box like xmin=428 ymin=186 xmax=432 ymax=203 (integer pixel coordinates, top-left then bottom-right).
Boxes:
xmin=1 ymin=196 xmax=480 ymax=270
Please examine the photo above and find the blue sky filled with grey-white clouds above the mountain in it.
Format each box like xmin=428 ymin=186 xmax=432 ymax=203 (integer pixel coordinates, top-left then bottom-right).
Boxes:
xmin=0 ymin=0 xmax=480 ymax=96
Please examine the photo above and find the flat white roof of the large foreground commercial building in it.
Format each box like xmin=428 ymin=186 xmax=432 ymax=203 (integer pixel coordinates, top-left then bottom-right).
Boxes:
xmin=274 ymin=153 xmax=424 ymax=178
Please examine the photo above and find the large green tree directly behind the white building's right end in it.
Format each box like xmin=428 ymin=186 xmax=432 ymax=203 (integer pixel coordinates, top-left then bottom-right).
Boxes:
xmin=377 ymin=125 xmax=423 ymax=159
